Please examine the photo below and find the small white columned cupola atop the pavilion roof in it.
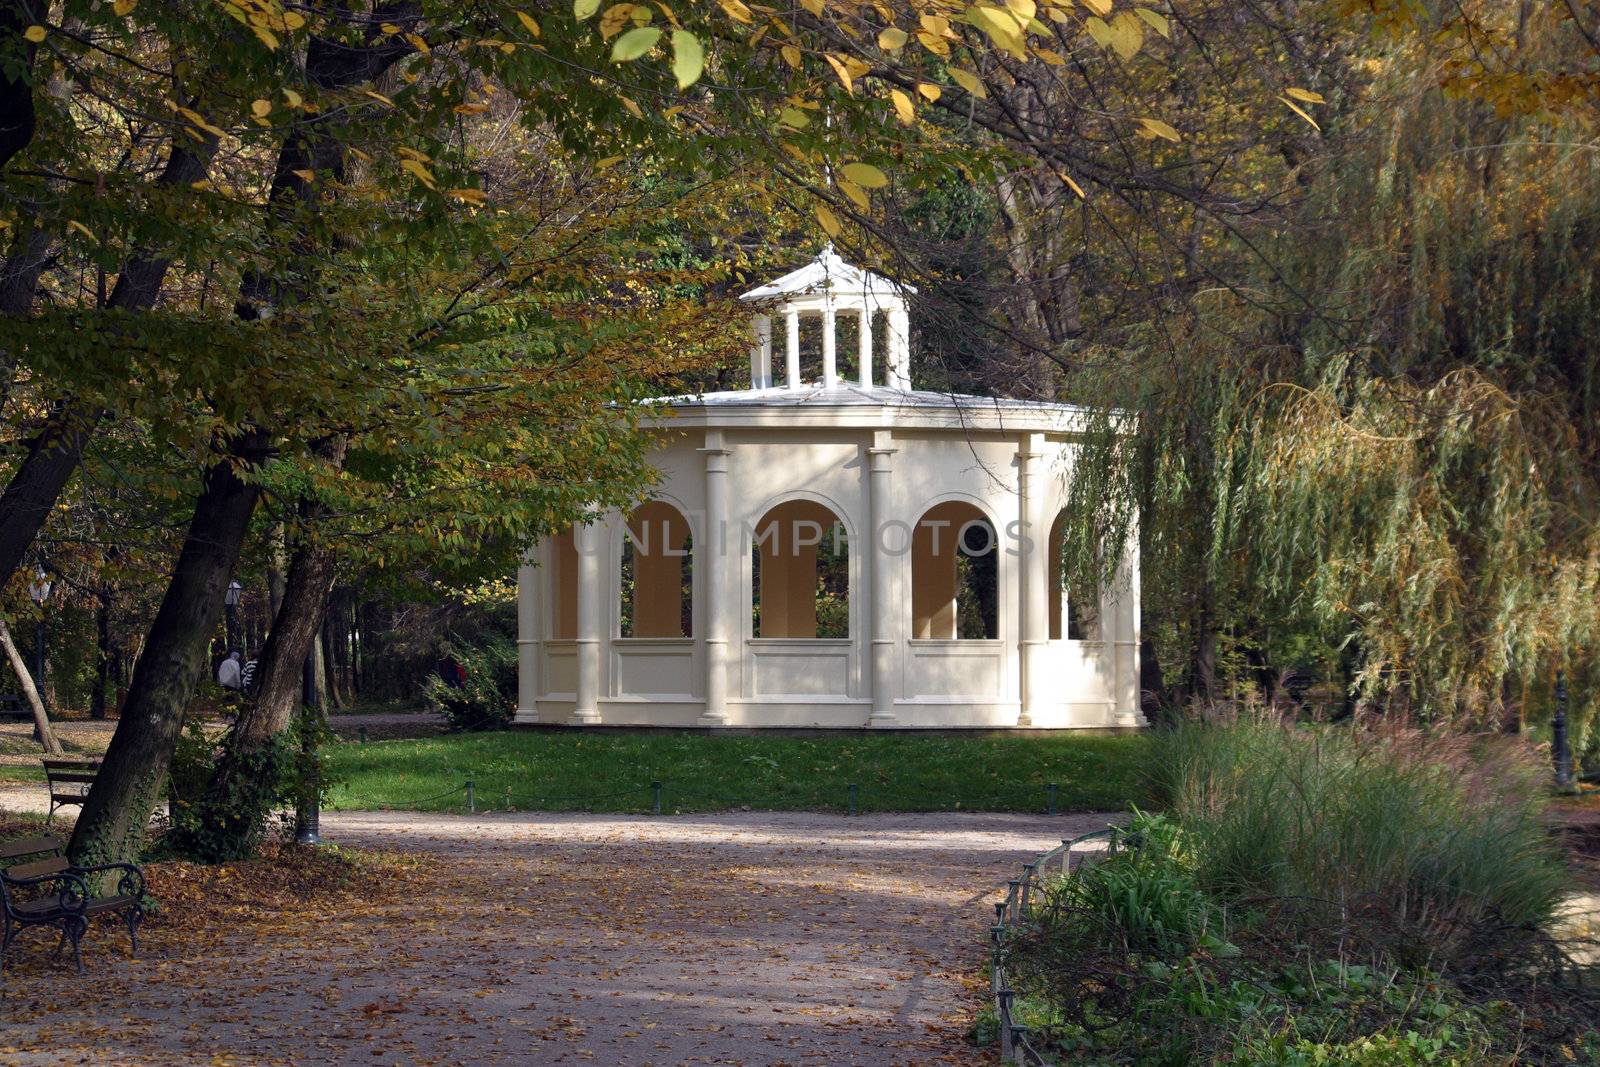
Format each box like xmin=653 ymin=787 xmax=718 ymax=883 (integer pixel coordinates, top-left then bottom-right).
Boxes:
xmin=739 ymin=245 xmax=917 ymax=392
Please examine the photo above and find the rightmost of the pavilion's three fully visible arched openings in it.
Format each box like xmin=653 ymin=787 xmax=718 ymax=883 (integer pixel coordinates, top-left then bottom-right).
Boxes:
xmin=910 ymin=501 xmax=1000 ymax=640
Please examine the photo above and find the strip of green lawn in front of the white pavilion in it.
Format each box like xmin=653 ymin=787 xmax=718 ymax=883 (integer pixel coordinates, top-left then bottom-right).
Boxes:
xmin=325 ymin=731 xmax=1149 ymax=813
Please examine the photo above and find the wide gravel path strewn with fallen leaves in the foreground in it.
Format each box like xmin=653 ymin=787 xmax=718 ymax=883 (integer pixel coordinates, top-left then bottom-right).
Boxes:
xmin=0 ymin=809 xmax=1106 ymax=1067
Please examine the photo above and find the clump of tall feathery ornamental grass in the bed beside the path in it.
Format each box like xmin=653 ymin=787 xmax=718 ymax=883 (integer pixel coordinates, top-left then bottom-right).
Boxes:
xmin=1157 ymin=720 xmax=1565 ymax=968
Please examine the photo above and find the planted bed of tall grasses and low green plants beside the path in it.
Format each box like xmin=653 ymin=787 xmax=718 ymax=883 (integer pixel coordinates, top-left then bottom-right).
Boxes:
xmin=1003 ymin=723 xmax=1600 ymax=1067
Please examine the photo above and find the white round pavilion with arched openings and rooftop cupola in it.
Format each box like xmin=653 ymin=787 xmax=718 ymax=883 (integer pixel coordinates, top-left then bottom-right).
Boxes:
xmin=517 ymin=248 xmax=1144 ymax=729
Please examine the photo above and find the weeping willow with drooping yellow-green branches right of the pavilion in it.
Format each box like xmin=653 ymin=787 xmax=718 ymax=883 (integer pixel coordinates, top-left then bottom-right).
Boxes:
xmin=1049 ymin=10 xmax=1600 ymax=745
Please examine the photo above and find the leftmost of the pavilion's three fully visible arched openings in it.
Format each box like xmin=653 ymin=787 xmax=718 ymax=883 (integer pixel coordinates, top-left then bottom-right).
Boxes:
xmin=619 ymin=501 xmax=694 ymax=637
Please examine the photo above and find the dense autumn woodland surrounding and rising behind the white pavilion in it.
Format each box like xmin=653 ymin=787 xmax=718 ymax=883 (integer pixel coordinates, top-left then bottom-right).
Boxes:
xmin=0 ymin=0 xmax=1600 ymax=851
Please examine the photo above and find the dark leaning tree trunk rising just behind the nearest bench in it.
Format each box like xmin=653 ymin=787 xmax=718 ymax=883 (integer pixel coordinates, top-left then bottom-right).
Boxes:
xmin=69 ymin=430 xmax=270 ymax=864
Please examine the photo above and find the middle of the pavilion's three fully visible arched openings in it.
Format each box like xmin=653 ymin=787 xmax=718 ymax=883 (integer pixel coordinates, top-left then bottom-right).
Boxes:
xmin=750 ymin=501 xmax=850 ymax=637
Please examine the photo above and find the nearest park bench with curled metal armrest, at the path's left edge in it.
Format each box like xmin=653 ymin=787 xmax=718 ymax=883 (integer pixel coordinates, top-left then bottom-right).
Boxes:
xmin=0 ymin=837 xmax=144 ymax=973
